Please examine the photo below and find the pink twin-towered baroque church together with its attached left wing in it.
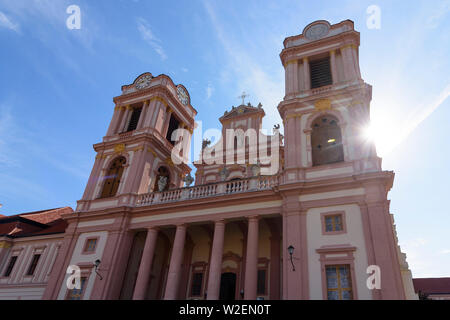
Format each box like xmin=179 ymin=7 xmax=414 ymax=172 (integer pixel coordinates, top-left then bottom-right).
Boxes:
xmin=0 ymin=20 xmax=416 ymax=300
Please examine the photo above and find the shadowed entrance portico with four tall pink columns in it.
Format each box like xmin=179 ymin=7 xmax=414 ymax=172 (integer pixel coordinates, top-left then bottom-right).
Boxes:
xmin=121 ymin=215 xmax=281 ymax=300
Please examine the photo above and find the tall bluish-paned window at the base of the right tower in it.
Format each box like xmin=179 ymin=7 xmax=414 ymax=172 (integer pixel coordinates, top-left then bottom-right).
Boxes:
xmin=326 ymin=264 xmax=353 ymax=300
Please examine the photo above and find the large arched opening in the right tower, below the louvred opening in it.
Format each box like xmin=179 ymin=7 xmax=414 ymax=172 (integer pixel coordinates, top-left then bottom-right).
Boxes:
xmin=311 ymin=115 xmax=344 ymax=166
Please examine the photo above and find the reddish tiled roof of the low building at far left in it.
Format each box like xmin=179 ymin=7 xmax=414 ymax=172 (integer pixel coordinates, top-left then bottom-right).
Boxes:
xmin=0 ymin=207 xmax=73 ymax=238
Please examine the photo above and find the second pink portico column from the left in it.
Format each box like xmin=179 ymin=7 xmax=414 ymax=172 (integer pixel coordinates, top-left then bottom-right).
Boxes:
xmin=164 ymin=225 xmax=186 ymax=300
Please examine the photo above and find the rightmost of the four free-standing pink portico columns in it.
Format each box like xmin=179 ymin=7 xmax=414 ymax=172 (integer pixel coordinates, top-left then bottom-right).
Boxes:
xmin=244 ymin=216 xmax=259 ymax=300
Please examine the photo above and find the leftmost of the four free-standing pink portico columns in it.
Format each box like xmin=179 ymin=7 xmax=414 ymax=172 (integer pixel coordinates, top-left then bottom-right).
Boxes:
xmin=133 ymin=228 xmax=158 ymax=300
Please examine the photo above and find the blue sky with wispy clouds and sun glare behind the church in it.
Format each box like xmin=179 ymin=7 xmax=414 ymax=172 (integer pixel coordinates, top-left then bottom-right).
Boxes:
xmin=0 ymin=0 xmax=450 ymax=277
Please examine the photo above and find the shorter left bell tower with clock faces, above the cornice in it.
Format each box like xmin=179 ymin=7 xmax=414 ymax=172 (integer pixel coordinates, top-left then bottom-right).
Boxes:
xmin=77 ymin=73 xmax=197 ymax=211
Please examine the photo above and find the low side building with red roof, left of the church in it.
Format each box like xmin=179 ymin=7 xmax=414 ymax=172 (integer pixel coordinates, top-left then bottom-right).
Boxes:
xmin=0 ymin=207 xmax=73 ymax=300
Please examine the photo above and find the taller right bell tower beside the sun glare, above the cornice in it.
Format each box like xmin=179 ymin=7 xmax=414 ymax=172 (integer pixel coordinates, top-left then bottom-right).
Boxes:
xmin=278 ymin=20 xmax=381 ymax=180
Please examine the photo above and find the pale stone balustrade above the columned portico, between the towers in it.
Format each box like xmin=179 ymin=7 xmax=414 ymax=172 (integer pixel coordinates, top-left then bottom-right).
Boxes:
xmin=136 ymin=176 xmax=278 ymax=206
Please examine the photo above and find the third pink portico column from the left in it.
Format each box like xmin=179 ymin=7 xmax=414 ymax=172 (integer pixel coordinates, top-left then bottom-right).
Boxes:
xmin=207 ymin=220 xmax=225 ymax=300
